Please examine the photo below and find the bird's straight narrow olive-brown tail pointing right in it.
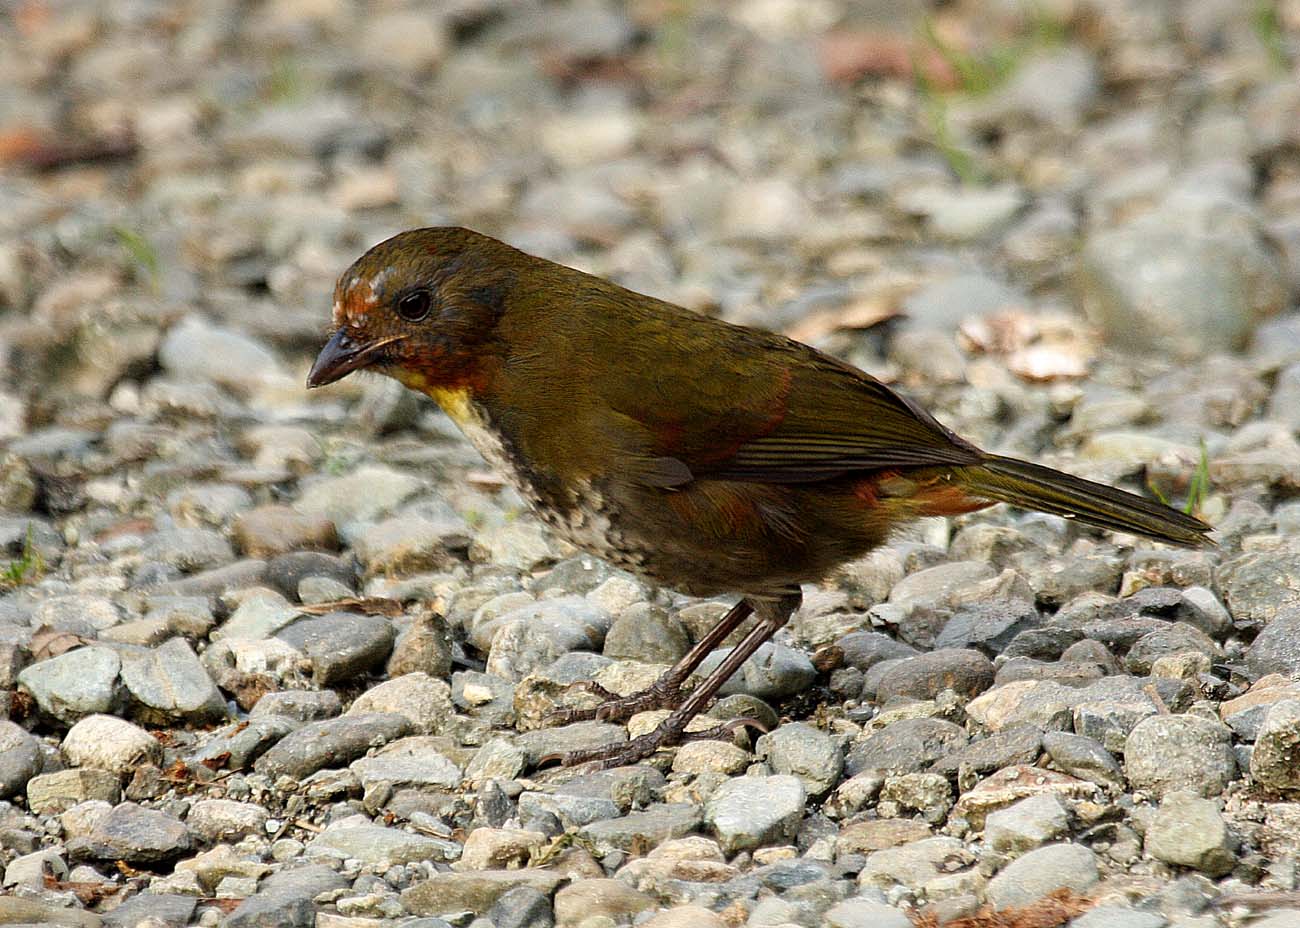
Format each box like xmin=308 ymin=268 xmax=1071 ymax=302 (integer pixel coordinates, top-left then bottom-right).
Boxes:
xmin=961 ymin=455 xmax=1214 ymax=547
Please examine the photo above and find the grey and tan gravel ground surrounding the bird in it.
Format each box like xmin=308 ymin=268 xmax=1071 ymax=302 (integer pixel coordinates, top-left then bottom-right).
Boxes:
xmin=0 ymin=0 xmax=1300 ymax=928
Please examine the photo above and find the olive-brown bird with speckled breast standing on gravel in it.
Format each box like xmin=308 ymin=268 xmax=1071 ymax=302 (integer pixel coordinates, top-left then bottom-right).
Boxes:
xmin=307 ymin=229 xmax=1210 ymax=766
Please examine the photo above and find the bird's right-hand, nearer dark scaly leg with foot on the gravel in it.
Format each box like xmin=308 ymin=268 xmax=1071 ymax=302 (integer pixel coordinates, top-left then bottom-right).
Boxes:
xmin=558 ymin=590 xmax=801 ymax=768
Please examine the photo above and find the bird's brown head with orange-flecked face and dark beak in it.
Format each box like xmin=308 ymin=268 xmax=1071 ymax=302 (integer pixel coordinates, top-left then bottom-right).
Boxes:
xmin=307 ymin=227 xmax=520 ymax=393
